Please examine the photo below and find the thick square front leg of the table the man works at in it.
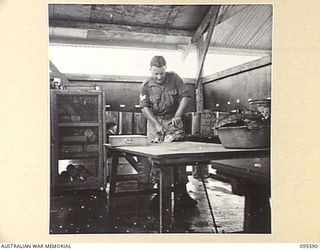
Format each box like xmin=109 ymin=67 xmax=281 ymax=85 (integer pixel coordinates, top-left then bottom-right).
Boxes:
xmin=159 ymin=167 xmax=172 ymax=233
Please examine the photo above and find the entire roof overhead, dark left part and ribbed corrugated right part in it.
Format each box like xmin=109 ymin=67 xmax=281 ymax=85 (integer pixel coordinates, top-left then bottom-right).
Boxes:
xmin=49 ymin=4 xmax=273 ymax=53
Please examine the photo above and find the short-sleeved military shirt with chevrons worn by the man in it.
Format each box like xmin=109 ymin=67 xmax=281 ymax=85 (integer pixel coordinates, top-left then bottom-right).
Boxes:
xmin=140 ymin=72 xmax=191 ymax=116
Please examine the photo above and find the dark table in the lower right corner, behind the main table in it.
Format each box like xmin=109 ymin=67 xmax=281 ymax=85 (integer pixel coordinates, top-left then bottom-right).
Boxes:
xmin=211 ymin=157 xmax=271 ymax=233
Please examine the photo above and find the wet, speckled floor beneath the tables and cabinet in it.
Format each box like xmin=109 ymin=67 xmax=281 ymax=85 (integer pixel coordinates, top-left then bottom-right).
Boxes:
xmin=50 ymin=175 xmax=244 ymax=234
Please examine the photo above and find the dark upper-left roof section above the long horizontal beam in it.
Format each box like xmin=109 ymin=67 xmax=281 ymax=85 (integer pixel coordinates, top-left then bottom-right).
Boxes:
xmin=49 ymin=4 xmax=210 ymax=31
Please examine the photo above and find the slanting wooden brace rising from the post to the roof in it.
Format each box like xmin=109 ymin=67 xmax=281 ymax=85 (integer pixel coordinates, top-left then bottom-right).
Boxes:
xmin=196 ymin=6 xmax=220 ymax=88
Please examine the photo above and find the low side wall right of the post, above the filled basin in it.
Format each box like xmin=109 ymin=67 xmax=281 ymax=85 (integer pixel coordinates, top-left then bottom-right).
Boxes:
xmin=203 ymin=56 xmax=272 ymax=111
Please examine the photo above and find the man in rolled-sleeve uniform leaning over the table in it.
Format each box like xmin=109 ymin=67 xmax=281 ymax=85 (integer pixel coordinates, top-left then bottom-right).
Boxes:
xmin=140 ymin=56 xmax=197 ymax=207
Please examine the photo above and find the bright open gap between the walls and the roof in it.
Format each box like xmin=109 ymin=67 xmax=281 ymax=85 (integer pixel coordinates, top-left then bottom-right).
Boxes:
xmin=49 ymin=44 xmax=260 ymax=78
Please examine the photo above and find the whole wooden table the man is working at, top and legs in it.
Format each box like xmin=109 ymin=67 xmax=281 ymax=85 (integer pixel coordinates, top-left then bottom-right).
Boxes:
xmin=105 ymin=141 xmax=270 ymax=233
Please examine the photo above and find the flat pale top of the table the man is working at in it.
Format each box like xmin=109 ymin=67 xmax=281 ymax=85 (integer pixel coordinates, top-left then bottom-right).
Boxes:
xmin=104 ymin=141 xmax=270 ymax=157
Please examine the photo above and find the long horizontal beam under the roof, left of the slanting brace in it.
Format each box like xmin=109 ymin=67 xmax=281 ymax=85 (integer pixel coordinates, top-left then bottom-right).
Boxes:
xmin=49 ymin=20 xmax=193 ymax=37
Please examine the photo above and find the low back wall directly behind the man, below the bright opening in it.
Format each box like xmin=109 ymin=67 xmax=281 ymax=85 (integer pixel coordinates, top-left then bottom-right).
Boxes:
xmin=50 ymin=74 xmax=195 ymax=134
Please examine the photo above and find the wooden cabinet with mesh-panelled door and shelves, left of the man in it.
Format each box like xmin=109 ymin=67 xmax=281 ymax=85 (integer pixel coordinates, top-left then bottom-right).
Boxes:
xmin=50 ymin=89 xmax=105 ymax=190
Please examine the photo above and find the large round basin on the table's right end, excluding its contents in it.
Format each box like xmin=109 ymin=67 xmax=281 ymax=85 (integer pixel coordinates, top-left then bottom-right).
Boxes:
xmin=218 ymin=126 xmax=270 ymax=148
